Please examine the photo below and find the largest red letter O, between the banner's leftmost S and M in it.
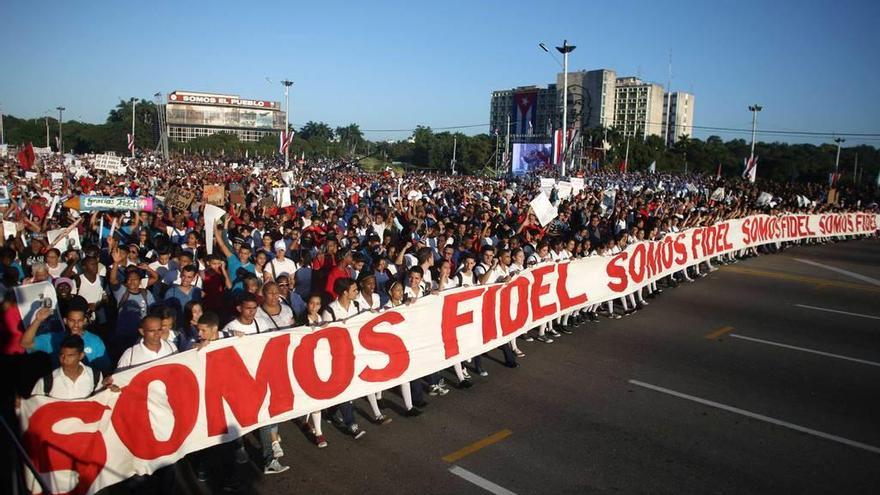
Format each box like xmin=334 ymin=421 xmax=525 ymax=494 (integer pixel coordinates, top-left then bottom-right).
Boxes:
xmin=110 ymin=364 xmax=199 ymax=461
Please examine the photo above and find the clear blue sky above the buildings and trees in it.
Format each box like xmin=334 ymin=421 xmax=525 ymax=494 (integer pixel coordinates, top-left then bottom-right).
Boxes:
xmin=0 ymin=0 xmax=880 ymax=145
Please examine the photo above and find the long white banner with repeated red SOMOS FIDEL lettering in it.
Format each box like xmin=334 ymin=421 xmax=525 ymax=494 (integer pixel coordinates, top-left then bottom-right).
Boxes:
xmin=20 ymin=213 xmax=878 ymax=493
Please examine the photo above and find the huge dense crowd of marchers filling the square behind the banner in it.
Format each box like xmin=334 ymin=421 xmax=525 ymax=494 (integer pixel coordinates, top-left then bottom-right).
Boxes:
xmin=0 ymin=151 xmax=877 ymax=488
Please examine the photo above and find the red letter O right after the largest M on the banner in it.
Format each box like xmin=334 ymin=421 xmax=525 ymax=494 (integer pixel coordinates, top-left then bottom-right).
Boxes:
xmin=293 ymin=327 xmax=354 ymax=399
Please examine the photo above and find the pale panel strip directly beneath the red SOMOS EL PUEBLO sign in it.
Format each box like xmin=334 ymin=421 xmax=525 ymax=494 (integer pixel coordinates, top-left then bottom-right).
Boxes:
xmin=165 ymin=104 xmax=284 ymax=129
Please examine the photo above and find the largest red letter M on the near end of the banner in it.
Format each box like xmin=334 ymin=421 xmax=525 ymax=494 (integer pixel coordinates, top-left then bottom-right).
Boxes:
xmin=205 ymin=334 xmax=293 ymax=436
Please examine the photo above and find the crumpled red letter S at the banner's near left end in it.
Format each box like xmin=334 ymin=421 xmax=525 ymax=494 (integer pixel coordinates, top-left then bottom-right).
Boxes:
xmin=21 ymin=401 xmax=108 ymax=495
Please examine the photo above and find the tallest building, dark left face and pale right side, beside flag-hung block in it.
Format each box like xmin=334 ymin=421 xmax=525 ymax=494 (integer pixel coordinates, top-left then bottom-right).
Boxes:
xmin=553 ymin=69 xmax=617 ymax=132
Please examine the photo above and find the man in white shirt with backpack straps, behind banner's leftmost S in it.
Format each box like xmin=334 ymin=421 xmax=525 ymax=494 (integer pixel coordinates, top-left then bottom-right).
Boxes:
xmin=31 ymin=334 xmax=101 ymax=399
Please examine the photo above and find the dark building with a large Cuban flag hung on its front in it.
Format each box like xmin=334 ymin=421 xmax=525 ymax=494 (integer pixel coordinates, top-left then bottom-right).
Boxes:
xmin=489 ymin=84 xmax=557 ymax=137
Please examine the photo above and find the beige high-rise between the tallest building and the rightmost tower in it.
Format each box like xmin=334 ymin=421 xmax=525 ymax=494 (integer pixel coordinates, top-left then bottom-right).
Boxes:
xmin=614 ymin=77 xmax=663 ymax=138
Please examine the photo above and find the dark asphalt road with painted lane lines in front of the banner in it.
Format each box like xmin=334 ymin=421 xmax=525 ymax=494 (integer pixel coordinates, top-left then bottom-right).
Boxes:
xmin=122 ymin=240 xmax=880 ymax=494
